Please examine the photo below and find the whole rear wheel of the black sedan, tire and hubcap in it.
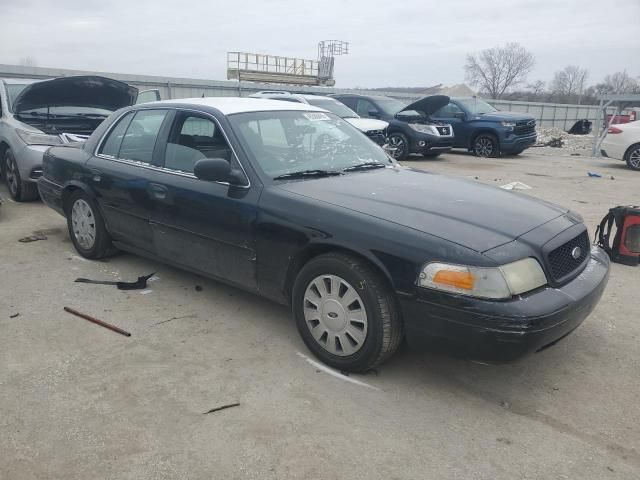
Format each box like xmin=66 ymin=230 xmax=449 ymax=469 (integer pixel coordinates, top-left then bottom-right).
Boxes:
xmin=65 ymin=190 xmax=115 ymax=259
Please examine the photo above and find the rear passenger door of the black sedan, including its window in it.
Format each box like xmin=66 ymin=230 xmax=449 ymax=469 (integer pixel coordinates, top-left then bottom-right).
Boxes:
xmin=87 ymin=109 xmax=174 ymax=253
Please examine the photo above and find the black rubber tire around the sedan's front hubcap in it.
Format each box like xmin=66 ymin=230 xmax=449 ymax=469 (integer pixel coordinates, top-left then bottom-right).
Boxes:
xmin=292 ymin=253 xmax=403 ymax=372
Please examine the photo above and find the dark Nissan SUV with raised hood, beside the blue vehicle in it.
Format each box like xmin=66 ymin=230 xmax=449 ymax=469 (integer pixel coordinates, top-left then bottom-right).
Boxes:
xmin=332 ymin=94 xmax=454 ymax=160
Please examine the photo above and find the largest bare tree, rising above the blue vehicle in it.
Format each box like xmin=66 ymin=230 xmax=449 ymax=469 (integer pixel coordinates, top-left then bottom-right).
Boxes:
xmin=464 ymin=43 xmax=535 ymax=98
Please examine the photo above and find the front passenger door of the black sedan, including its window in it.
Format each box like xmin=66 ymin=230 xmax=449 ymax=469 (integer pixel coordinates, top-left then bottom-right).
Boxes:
xmin=150 ymin=112 xmax=259 ymax=289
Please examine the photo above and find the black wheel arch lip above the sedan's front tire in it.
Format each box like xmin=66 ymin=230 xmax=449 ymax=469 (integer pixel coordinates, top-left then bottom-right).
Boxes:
xmin=284 ymin=243 xmax=395 ymax=303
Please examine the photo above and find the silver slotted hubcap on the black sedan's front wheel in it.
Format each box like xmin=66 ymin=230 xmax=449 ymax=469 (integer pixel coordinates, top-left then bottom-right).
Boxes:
xmin=304 ymin=275 xmax=368 ymax=357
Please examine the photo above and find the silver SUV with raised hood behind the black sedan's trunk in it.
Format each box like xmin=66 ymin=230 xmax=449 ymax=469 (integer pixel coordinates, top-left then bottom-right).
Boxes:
xmin=0 ymin=76 xmax=160 ymax=202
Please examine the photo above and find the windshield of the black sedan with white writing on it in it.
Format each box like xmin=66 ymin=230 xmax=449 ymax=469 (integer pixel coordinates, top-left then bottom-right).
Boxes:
xmin=228 ymin=111 xmax=393 ymax=178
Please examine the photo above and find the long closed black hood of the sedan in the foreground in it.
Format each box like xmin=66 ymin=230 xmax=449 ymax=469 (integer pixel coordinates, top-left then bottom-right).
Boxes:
xmin=278 ymin=167 xmax=567 ymax=252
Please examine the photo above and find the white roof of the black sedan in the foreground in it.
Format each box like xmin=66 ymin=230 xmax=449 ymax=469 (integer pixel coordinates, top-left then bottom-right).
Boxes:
xmin=149 ymin=97 xmax=326 ymax=115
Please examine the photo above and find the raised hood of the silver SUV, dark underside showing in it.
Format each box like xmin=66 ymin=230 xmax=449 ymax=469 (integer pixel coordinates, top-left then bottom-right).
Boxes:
xmin=13 ymin=76 xmax=138 ymax=114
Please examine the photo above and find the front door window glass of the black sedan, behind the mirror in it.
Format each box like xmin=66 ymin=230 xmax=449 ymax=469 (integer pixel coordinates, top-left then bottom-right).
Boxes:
xmin=164 ymin=113 xmax=231 ymax=173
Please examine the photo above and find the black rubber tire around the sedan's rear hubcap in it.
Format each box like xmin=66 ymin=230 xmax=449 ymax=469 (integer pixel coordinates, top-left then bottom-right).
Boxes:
xmin=65 ymin=190 xmax=116 ymax=260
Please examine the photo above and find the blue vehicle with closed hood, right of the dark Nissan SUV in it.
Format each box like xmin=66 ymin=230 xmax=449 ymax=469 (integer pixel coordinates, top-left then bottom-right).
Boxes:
xmin=431 ymin=97 xmax=536 ymax=157
